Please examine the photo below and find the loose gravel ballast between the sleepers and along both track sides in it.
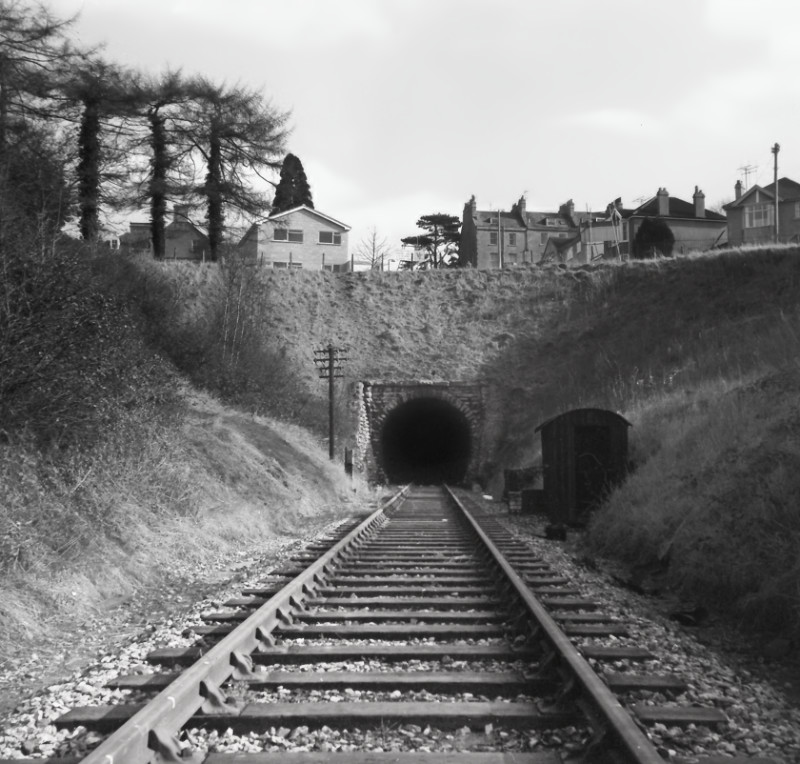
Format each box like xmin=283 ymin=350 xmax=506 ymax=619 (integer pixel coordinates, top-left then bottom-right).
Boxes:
xmin=0 ymin=505 xmax=800 ymax=764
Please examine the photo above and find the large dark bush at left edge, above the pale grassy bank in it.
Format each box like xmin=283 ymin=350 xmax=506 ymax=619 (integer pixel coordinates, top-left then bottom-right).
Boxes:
xmin=0 ymin=242 xmax=180 ymax=447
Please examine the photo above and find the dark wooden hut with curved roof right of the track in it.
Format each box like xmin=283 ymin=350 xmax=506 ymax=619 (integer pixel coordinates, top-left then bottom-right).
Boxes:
xmin=536 ymin=408 xmax=631 ymax=525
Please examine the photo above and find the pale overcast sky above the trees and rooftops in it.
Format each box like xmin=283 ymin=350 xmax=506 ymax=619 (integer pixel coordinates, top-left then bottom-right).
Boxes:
xmin=46 ymin=0 xmax=800 ymax=256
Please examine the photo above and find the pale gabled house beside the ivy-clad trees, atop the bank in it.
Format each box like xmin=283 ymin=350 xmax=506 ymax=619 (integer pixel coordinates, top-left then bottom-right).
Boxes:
xmin=238 ymin=204 xmax=350 ymax=271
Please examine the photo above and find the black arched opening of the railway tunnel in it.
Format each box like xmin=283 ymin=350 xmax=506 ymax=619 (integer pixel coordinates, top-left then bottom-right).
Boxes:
xmin=381 ymin=398 xmax=472 ymax=485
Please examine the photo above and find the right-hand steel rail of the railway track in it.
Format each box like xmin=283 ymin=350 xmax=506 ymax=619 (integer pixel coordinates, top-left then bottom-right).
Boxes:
xmin=446 ymin=487 xmax=664 ymax=764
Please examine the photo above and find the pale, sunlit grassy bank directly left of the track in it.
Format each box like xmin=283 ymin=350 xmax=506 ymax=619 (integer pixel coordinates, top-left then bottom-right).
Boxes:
xmin=0 ymin=386 xmax=370 ymax=675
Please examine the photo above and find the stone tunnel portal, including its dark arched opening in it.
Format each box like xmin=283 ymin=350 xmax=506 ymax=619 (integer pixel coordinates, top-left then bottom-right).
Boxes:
xmin=353 ymin=380 xmax=485 ymax=484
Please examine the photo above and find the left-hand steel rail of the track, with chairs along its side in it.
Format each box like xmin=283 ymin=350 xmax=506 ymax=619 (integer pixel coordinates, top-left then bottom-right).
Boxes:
xmin=81 ymin=487 xmax=408 ymax=764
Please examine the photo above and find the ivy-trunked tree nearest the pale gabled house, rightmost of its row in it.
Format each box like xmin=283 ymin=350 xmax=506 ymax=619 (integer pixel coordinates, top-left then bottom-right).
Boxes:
xmin=181 ymin=78 xmax=288 ymax=260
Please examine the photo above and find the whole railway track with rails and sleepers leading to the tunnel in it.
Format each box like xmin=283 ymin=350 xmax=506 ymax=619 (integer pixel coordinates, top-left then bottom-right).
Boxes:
xmin=7 ymin=488 xmax=752 ymax=764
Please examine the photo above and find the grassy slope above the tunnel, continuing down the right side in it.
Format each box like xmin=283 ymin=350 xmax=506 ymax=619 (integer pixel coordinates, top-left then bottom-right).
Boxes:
xmin=144 ymin=248 xmax=800 ymax=626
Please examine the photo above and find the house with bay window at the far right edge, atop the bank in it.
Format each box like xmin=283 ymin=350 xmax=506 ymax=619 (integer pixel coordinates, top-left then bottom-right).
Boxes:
xmin=724 ymin=178 xmax=800 ymax=247
